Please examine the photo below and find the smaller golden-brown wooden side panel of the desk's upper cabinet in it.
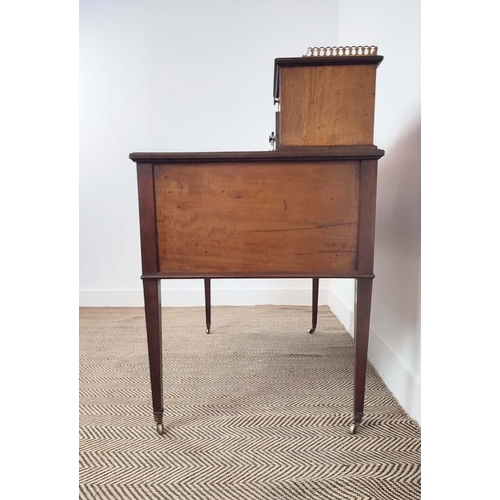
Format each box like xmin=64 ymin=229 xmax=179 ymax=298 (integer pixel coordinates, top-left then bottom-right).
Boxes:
xmin=279 ymin=65 xmax=376 ymax=147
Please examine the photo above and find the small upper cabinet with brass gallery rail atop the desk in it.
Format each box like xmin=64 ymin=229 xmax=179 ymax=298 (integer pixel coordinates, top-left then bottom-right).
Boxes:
xmin=274 ymin=47 xmax=383 ymax=149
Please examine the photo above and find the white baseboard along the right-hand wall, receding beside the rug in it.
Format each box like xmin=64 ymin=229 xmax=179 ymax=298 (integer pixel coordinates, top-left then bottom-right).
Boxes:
xmin=328 ymin=289 xmax=421 ymax=424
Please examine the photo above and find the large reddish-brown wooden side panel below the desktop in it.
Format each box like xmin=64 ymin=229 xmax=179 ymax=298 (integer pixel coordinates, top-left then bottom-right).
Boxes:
xmin=154 ymin=160 xmax=360 ymax=277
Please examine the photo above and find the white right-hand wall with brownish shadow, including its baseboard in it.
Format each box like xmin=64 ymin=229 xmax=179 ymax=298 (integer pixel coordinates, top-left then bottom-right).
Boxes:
xmin=329 ymin=0 xmax=420 ymax=421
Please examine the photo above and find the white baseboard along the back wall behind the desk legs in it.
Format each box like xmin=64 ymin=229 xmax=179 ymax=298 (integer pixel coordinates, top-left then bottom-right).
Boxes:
xmin=80 ymin=280 xmax=330 ymax=307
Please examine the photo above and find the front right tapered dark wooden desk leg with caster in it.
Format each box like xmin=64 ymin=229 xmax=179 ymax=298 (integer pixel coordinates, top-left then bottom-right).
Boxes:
xmin=349 ymin=278 xmax=373 ymax=434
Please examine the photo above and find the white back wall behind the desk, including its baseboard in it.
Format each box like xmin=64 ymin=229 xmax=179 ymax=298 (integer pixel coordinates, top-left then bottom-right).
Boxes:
xmin=80 ymin=0 xmax=339 ymax=306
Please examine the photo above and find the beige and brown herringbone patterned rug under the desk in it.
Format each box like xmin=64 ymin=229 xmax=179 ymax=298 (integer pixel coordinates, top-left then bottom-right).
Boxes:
xmin=80 ymin=306 xmax=420 ymax=500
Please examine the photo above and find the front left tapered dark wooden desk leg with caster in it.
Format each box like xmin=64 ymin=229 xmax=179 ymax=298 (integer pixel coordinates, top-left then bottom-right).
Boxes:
xmin=143 ymin=279 xmax=163 ymax=434
